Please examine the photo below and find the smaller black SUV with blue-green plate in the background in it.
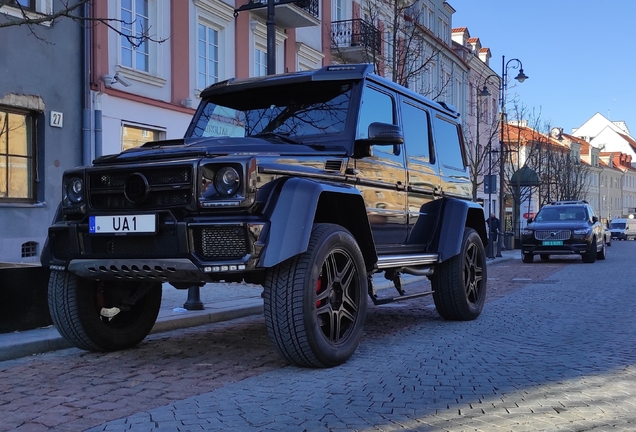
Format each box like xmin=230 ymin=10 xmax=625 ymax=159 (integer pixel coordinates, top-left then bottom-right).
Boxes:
xmin=521 ymin=201 xmax=606 ymax=263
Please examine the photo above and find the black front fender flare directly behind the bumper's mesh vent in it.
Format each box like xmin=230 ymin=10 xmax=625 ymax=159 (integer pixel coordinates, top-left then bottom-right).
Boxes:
xmin=258 ymin=177 xmax=377 ymax=267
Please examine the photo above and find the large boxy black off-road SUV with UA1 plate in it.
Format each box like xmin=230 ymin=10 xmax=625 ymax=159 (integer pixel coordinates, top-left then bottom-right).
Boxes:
xmin=48 ymin=65 xmax=487 ymax=367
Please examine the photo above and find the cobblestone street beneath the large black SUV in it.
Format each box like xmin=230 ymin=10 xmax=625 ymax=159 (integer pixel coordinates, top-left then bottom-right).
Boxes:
xmin=0 ymin=242 xmax=636 ymax=432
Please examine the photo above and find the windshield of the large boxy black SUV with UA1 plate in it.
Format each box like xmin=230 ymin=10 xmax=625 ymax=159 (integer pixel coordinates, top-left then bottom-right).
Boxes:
xmin=191 ymin=81 xmax=353 ymax=142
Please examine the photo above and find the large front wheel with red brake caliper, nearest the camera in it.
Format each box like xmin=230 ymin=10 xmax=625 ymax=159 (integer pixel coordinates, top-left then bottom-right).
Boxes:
xmin=263 ymin=223 xmax=367 ymax=368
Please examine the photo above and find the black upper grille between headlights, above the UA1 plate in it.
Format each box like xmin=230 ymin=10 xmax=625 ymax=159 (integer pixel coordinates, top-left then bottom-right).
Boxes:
xmin=88 ymin=165 xmax=193 ymax=210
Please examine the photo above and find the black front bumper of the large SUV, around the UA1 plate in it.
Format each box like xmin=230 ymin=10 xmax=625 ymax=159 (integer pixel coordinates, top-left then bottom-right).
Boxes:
xmin=49 ymin=212 xmax=269 ymax=283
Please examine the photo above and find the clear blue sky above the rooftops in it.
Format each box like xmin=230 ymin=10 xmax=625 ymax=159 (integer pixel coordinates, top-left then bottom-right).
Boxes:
xmin=448 ymin=0 xmax=636 ymax=136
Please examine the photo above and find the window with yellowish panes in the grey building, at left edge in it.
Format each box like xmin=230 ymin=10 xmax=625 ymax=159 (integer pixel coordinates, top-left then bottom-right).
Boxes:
xmin=0 ymin=107 xmax=36 ymax=202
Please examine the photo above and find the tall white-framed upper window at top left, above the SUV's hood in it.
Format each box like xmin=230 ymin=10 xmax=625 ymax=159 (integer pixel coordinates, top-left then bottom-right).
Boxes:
xmin=120 ymin=0 xmax=150 ymax=72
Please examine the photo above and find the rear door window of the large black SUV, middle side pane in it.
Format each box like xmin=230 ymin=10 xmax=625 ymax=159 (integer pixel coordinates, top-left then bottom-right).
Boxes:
xmin=402 ymin=101 xmax=434 ymax=163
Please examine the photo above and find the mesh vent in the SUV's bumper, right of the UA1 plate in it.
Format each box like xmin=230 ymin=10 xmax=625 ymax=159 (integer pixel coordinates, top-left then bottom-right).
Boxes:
xmin=192 ymin=226 xmax=248 ymax=259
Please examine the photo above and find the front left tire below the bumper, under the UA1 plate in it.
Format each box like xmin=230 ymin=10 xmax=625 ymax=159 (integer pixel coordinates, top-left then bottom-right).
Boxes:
xmin=48 ymin=271 xmax=161 ymax=351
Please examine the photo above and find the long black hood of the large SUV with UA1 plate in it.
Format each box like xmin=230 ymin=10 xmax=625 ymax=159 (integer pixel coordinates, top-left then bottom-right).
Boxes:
xmin=93 ymin=137 xmax=347 ymax=165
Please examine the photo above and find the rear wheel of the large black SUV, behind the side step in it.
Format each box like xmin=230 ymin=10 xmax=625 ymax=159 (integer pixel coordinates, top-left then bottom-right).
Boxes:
xmin=431 ymin=228 xmax=488 ymax=321
